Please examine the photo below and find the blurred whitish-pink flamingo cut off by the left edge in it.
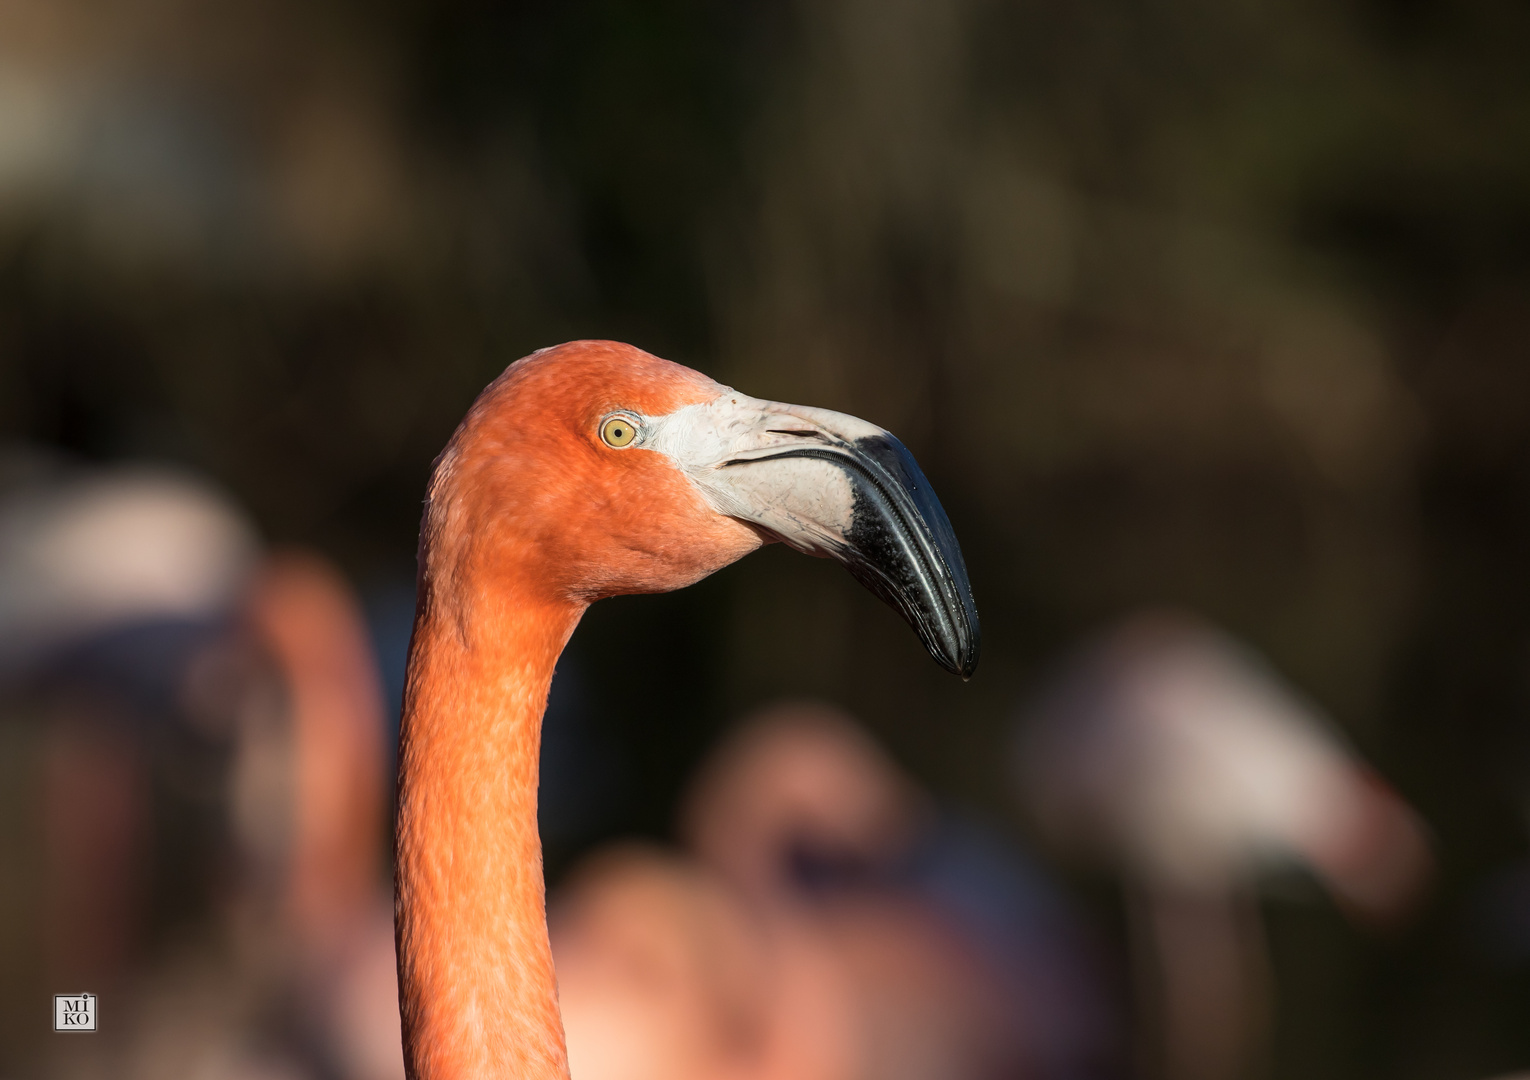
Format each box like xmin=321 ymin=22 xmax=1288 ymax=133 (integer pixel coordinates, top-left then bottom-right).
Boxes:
xmin=0 ymin=465 xmax=259 ymax=1009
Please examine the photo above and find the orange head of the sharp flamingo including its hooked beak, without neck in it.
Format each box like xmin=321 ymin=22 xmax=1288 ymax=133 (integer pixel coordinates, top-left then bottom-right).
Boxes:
xmin=422 ymin=341 xmax=979 ymax=676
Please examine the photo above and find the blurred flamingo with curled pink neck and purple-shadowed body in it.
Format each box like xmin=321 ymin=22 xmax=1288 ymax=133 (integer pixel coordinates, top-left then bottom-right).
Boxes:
xmin=682 ymin=702 xmax=1114 ymax=1080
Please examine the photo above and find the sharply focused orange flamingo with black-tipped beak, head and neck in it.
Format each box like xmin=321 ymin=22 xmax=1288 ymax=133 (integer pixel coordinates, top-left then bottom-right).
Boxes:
xmin=395 ymin=341 xmax=978 ymax=1080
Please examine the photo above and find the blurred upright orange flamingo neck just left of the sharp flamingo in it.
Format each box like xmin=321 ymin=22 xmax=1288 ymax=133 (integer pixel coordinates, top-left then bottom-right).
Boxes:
xmin=245 ymin=551 xmax=404 ymax=1080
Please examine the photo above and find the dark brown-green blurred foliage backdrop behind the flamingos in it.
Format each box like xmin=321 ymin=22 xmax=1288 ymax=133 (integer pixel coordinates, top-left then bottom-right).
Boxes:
xmin=0 ymin=0 xmax=1530 ymax=1078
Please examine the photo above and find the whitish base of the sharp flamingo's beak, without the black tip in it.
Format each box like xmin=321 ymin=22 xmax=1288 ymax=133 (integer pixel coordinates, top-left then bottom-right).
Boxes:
xmin=641 ymin=390 xmax=883 ymax=555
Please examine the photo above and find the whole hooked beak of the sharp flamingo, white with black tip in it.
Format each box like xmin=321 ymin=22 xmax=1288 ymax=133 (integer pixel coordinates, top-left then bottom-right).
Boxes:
xmin=644 ymin=390 xmax=979 ymax=679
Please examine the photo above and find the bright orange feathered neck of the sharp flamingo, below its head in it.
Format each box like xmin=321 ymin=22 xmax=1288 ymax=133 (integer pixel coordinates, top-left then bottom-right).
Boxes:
xmin=396 ymin=581 xmax=583 ymax=1080
